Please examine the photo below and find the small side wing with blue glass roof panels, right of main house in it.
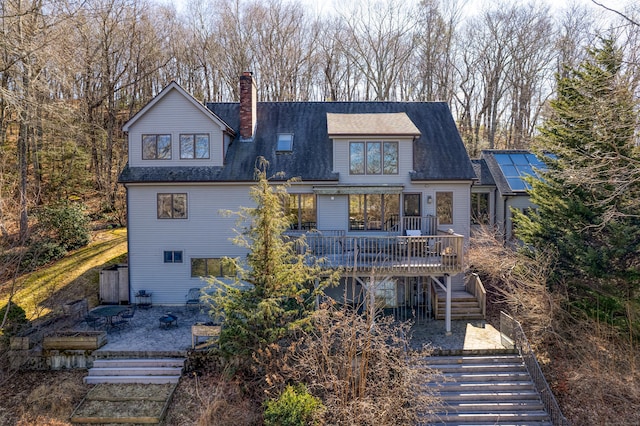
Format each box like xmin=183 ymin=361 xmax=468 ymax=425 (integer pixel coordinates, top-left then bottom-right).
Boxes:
xmin=471 ymin=149 xmax=546 ymax=241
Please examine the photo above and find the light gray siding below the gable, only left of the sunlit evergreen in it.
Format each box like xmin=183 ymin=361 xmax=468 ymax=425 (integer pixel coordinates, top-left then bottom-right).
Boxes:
xmin=128 ymin=185 xmax=252 ymax=304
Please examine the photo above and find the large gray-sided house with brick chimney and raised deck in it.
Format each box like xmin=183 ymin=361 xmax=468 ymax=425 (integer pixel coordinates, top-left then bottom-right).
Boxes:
xmin=119 ymin=73 xmax=482 ymax=332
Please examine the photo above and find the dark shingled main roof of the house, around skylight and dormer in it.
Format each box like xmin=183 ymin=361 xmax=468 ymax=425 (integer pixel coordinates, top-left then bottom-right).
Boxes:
xmin=120 ymin=102 xmax=476 ymax=182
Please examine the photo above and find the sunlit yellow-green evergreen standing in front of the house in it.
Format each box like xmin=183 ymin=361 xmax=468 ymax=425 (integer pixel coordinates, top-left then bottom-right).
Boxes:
xmin=205 ymin=159 xmax=336 ymax=362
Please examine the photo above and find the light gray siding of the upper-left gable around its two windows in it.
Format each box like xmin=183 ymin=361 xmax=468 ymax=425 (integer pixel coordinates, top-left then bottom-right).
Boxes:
xmin=129 ymin=90 xmax=224 ymax=167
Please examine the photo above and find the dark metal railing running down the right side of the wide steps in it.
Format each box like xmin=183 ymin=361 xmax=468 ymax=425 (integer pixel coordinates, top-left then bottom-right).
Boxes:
xmin=500 ymin=312 xmax=570 ymax=426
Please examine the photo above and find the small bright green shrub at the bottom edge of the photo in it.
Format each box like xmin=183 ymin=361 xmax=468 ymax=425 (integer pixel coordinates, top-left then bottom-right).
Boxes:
xmin=264 ymin=384 xmax=323 ymax=426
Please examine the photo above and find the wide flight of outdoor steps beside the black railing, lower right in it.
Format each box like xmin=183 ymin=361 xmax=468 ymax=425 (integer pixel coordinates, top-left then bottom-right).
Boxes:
xmin=420 ymin=354 xmax=551 ymax=426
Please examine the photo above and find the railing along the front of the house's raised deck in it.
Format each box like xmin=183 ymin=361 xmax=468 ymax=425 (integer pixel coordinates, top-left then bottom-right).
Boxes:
xmin=292 ymin=231 xmax=464 ymax=275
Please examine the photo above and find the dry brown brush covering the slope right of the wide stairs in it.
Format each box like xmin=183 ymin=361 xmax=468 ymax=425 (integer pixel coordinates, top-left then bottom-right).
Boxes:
xmin=469 ymin=225 xmax=640 ymax=425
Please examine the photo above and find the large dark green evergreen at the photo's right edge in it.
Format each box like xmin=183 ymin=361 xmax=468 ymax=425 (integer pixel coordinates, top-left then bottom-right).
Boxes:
xmin=515 ymin=39 xmax=640 ymax=306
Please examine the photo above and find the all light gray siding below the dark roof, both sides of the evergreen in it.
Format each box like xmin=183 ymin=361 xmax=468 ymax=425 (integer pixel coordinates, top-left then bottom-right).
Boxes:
xmin=128 ymin=182 xmax=470 ymax=305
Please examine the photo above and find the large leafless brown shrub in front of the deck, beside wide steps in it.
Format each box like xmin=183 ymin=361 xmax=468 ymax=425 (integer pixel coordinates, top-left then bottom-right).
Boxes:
xmin=259 ymin=307 xmax=437 ymax=425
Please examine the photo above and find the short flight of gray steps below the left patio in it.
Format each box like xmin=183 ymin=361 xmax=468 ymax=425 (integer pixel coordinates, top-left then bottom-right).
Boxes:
xmin=84 ymin=358 xmax=185 ymax=384
